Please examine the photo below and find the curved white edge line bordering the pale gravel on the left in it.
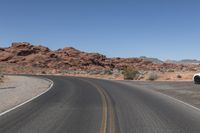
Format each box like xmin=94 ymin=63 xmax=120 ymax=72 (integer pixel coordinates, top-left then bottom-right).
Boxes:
xmin=0 ymin=77 xmax=54 ymax=116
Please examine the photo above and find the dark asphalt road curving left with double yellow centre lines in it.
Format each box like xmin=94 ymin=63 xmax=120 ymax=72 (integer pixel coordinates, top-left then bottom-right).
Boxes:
xmin=0 ymin=76 xmax=200 ymax=133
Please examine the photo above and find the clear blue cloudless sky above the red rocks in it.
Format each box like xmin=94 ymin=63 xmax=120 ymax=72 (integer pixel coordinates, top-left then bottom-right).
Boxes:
xmin=0 ymin=0 xmax=200 ymax=60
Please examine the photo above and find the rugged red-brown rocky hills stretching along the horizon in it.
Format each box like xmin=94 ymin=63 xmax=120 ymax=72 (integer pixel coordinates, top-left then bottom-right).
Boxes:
xmin=0 ymin=42 xmax=199 ymax=75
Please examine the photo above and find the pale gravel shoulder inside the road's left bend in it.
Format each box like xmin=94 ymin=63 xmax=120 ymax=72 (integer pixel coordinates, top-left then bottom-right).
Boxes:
xmin=0 ymin=76 xmax=51 ymax=113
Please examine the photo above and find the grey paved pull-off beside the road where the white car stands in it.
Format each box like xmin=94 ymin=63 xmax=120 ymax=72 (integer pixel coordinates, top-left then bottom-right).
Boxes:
xmin=119 ymin=81 xmax=200 ymax=108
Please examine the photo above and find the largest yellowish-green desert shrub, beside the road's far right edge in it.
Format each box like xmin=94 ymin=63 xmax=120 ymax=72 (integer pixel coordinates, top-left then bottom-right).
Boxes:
xmin=122 ymin=67 xmax=139 ymax=80
